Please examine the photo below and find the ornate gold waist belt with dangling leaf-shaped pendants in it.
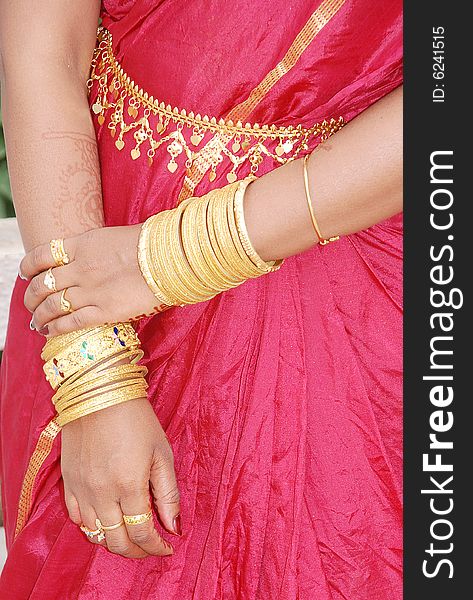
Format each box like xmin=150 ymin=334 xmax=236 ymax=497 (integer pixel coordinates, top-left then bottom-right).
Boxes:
xmin=87 ymin=27 xmax=344 ymax=183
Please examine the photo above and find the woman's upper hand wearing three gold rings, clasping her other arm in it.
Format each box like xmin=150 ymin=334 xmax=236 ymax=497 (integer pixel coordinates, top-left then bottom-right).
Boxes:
xmin=20 ymin=225 xmax=160 ymax=336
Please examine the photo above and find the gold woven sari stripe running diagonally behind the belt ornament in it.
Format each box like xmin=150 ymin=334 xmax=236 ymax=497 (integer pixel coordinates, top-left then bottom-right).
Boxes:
xmin=179 ymin=0 xmax=345 ymax=202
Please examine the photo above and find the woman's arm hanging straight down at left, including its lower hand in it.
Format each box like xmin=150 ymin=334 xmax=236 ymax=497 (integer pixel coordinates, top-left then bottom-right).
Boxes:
xmin=0 ymin=0 xmax=179 ymax=557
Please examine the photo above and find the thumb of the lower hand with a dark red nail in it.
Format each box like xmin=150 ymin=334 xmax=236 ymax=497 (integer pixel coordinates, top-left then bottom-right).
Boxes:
xmin=150 ymin=446 xmax=182 ymax=535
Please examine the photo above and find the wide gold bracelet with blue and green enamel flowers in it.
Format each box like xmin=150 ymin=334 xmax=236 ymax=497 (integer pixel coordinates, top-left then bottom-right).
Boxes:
xmin=43 ymin=323 xmax=140 ymax=389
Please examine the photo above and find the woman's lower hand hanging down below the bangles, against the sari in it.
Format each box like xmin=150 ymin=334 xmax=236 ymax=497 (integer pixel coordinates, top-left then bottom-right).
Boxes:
xmin=62 ymin=398 xmax=182 ymax=558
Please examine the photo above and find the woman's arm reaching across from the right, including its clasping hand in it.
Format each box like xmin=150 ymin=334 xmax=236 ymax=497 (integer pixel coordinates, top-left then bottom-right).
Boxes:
xmin=21 ymin=82 xmax=402 ymax=335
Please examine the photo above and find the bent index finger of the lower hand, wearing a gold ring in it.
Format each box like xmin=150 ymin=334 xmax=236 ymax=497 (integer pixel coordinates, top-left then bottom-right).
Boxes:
xmin=120 ymin=493 xmax=174 ymax=556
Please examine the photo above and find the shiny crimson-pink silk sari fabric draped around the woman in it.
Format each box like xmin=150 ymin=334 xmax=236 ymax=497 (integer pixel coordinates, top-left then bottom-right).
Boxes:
xmin=0 ymin=0 xmax=402 ymax=600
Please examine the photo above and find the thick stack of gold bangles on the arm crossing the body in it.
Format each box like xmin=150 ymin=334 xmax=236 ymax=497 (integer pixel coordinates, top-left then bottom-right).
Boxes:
xmin=138 ymin=177 xmax=283 ymax=308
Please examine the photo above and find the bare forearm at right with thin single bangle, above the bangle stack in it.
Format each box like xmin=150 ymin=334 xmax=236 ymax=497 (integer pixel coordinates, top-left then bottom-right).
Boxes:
xmin=245 ymin=88 xmax=402 ymax=260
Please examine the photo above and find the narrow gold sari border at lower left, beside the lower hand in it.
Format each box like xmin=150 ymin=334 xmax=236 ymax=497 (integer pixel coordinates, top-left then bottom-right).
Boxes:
xmin=15 ymin=419 xmax=61 ymax=538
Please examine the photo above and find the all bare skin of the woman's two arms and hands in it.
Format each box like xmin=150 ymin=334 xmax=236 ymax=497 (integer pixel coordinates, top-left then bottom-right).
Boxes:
xmin=0 ymin=0 xmax=402 ymax=556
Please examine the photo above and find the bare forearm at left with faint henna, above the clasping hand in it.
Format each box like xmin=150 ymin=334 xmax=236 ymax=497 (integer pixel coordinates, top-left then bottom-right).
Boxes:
xmin=1 ymin=1 xmax=103 ymax=250
